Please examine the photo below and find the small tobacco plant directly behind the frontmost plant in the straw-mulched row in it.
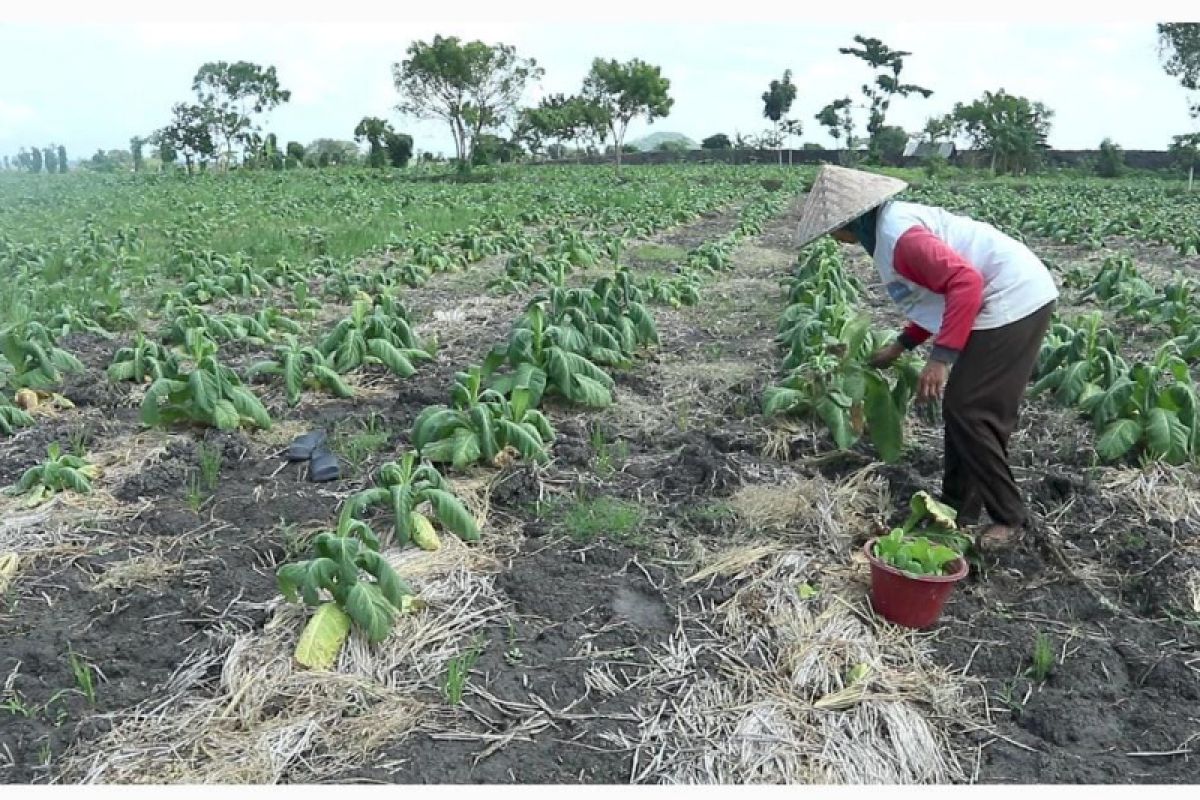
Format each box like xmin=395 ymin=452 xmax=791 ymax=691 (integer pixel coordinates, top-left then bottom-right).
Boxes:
xmin=340 ymin=452 xmax=479 ymax=549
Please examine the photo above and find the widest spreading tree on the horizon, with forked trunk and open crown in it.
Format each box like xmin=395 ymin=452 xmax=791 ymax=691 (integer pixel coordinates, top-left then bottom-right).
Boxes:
xmin=391 ymin=36 xmax=544 ymax=166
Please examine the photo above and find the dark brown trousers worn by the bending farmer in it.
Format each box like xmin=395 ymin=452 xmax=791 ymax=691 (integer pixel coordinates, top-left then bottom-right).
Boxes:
xmin=942 ymin=302 xmax=1055 ymax=528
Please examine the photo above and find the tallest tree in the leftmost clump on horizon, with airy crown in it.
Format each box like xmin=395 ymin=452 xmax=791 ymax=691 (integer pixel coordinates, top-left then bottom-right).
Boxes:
xmin=192 ymin=61 xmax=292 ymax=166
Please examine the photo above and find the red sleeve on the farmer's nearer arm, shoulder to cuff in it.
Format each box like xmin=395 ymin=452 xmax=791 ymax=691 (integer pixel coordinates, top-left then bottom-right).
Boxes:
xmin=892 ymin=225 xmax=983 ymax=360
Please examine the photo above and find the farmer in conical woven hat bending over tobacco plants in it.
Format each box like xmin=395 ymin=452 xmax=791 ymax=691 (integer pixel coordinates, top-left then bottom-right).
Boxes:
xmin=797 ymin=167 xmax=1058 ymax=548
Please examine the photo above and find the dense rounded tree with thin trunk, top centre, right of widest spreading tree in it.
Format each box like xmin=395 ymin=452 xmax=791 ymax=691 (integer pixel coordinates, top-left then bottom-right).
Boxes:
xmin=583 ymin=59 xmax=674 ymax=169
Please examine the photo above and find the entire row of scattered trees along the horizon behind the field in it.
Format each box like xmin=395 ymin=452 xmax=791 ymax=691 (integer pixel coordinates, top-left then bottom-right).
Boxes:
xmin=4 ymin=23 xmax=1200 ymax=175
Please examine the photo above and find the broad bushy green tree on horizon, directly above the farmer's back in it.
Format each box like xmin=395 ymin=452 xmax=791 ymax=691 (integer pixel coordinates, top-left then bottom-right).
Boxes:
xmin=944 ymin=89 xmax=1054 ymax=174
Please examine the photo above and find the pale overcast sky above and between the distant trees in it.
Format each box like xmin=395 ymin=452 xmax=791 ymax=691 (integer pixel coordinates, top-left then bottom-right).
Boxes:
xmin=0 ymin=7 xmax=1194 ymax=157
